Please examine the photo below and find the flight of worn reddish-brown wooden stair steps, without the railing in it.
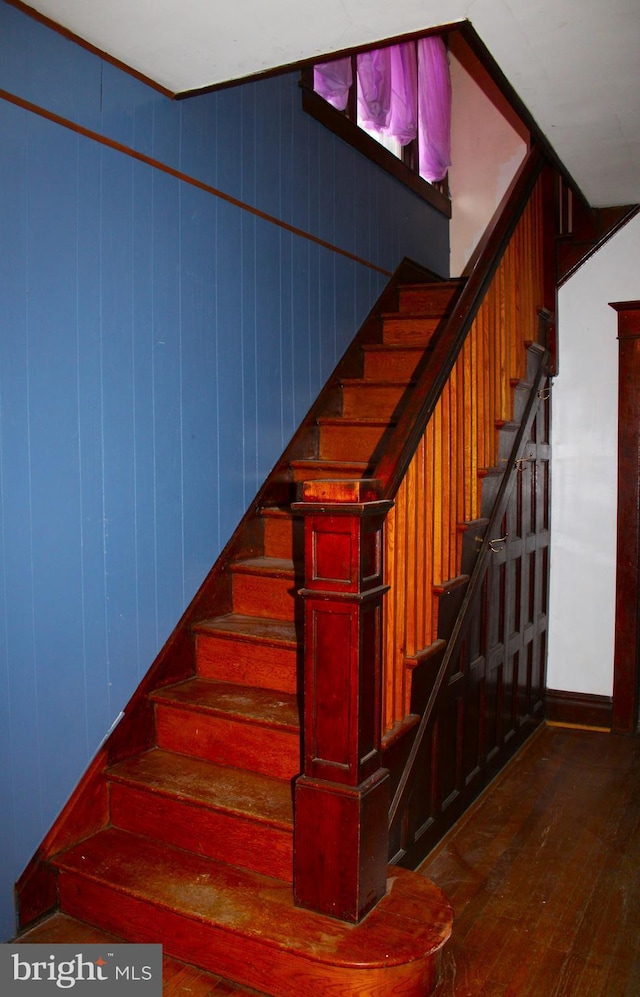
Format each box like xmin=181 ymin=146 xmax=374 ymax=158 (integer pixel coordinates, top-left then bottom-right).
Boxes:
xmin=18 ymin=264 xmax=459 ymax=997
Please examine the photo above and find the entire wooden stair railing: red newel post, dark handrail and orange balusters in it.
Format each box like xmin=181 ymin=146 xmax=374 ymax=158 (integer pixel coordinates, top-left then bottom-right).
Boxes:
xmin=294 ymin=149 xmax=552 ymax=921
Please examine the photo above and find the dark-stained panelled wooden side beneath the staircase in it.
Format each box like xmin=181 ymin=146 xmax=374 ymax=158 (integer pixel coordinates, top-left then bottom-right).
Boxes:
xmin=391 ymin=374 xmax=550 ymax=867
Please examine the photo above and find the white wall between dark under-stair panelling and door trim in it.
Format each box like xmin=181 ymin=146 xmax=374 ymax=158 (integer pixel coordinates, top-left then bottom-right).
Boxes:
xmin=547 ymin=216 xmax=640 ymax=696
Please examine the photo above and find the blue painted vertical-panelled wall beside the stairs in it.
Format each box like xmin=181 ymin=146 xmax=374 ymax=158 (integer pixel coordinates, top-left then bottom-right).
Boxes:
xmin=0 ymin=2 xmax=448 ymax=939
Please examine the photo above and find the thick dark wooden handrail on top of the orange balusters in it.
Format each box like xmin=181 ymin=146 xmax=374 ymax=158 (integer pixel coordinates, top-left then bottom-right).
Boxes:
xmin=374 ymin=147 xmax=545 ymax=499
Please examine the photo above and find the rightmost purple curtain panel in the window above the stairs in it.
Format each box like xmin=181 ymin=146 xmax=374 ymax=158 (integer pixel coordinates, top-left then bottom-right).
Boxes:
xmin=418 ymin=35 xmax=451 ymax=183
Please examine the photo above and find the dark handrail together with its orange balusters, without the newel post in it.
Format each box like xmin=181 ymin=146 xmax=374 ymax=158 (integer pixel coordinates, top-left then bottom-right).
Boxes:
xmin=375 ymin=153 xmax=546 ymax=734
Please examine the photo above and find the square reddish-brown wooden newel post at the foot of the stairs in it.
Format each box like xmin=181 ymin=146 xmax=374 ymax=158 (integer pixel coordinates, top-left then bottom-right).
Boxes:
xmin=294 ymin=480 xmax=392 ymax=922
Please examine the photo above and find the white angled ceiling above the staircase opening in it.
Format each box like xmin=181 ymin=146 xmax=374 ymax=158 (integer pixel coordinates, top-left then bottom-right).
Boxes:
xmin=22 ymin=0 xmax=640 ymax=206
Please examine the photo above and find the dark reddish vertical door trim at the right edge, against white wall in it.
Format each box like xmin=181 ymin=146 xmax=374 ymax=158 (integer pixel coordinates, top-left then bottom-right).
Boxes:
xmin=611 ymin=301 xmax=640 ymax=734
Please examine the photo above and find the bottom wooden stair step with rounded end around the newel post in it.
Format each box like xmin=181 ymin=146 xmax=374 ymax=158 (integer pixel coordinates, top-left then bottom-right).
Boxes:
xmin=54 ymin=828 xmax=452 ymax=997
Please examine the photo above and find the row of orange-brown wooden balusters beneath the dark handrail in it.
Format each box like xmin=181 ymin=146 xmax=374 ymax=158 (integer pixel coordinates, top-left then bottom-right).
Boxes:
xmin=383 ymin=171 xmax=544 ymax=733
